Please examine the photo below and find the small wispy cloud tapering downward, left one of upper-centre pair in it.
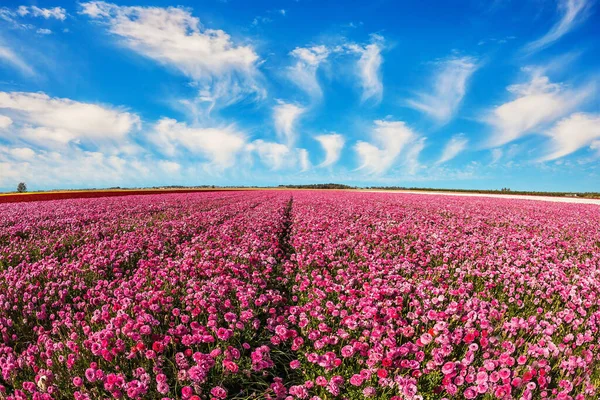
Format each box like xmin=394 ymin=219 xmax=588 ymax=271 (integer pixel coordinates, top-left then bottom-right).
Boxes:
xmin=287 ymin=45 xmax=330 ymax=98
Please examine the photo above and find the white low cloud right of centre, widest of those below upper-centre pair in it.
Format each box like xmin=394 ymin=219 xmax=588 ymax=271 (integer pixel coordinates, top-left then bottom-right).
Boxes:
xmin=354 ymin=120 xmax=425 ymax=175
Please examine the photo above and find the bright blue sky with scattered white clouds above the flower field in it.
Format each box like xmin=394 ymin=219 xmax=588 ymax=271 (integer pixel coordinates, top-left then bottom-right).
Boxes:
xmin=0 ymin=0 xmax=600 ymax=191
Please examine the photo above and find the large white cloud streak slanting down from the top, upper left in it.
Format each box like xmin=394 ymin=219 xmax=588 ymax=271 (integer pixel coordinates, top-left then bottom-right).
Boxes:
xmin=81 ymin=1 xmax=264 ymax=104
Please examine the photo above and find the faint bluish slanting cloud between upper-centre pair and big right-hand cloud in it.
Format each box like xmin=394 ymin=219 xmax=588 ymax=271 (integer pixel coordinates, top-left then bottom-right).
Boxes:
xmin=408 ymin=57 xmax=477 ymax=124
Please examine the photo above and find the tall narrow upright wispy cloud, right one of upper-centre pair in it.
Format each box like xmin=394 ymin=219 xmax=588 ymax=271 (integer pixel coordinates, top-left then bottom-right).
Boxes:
xmin=349 ymin=34 xmax=383 ymax=102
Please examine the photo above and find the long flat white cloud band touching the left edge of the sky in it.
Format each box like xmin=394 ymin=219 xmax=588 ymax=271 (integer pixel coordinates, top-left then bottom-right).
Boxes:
xmin=0 ymin=92 xmax=141 ymax=147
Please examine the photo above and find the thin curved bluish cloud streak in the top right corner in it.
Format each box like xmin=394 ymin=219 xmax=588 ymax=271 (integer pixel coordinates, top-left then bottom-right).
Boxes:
xmin=525 ymin=0 xmax=592 ymax=52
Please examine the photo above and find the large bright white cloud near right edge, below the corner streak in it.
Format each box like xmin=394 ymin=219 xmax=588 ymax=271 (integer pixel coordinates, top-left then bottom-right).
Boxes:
xmin=483 ymin=70 xmax=595 ymax=147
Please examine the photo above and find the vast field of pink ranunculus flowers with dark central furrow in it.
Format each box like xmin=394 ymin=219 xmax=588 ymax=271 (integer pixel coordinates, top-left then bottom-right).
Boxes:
xmin=0 ymin=191 xmax=600 ymax=400
